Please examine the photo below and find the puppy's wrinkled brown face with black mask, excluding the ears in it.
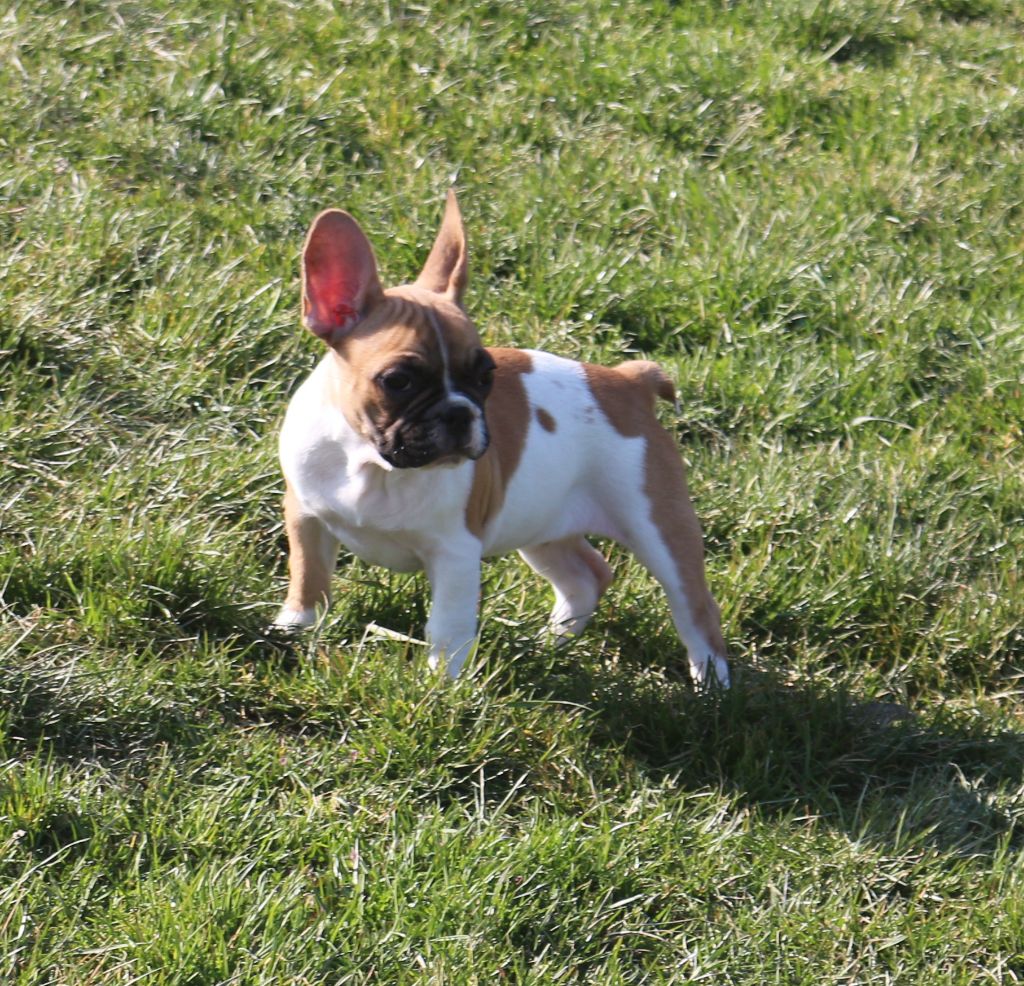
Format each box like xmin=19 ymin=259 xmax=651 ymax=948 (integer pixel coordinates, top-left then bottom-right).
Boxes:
xmin=335 ymin=287 xmax=495 ymax=469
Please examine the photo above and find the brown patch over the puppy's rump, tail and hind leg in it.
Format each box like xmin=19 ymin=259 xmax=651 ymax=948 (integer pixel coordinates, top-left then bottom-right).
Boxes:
xmin=584 ymin=359 xmax=725 ymax=655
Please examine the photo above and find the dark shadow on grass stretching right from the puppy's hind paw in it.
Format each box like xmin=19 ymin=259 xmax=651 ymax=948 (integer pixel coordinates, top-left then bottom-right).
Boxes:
xmin=520 ymin=647 xmax=1024 ymax=854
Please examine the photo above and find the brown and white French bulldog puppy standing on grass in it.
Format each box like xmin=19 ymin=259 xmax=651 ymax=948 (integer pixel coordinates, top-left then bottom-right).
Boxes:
xmin=274 ymin=191 xmax=729 ymax=685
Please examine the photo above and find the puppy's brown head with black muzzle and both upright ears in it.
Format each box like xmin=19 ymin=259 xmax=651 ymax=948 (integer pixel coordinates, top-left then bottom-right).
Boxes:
xmin=302 ymin=191 xmax=495 ymax=469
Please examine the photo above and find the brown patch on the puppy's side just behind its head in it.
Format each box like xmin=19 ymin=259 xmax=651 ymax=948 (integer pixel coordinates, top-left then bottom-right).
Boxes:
xmin=466 ymin=349 xmax=534 ymax=539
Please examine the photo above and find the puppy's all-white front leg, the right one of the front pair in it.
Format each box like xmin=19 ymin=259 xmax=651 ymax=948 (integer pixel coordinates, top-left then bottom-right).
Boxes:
xmin=425 ymin=539 xmax=480 ymax=678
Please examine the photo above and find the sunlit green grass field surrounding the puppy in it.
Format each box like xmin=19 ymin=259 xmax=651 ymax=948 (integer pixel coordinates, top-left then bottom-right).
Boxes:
xmin=0 ymin=0 xmax=1024 ymax=986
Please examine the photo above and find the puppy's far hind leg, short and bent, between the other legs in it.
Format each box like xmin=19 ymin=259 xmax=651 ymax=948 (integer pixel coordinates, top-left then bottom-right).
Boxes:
xmin=519 ymin=537 xmax=611 ymax=641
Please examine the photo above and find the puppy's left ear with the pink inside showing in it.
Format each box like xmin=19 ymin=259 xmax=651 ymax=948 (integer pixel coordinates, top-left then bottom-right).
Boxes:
xmin=302 ymin=209 xmax=384 ymax=344
